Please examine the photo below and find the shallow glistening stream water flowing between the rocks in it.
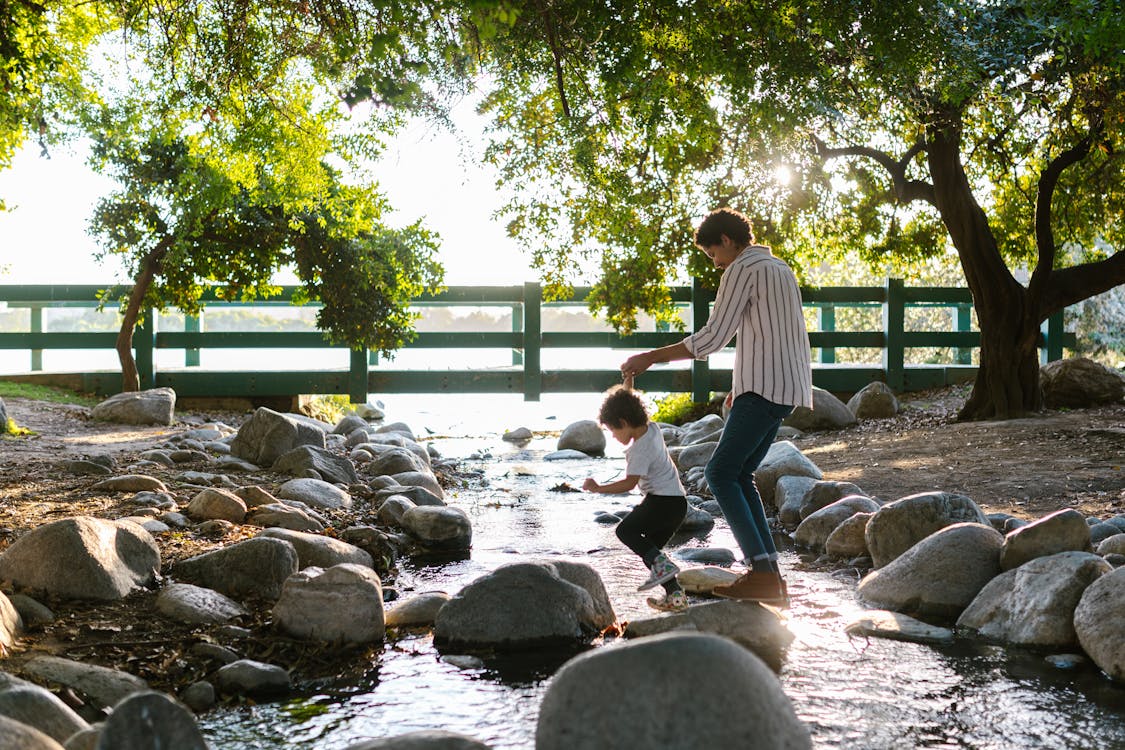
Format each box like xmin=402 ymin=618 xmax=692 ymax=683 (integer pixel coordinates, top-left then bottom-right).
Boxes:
xmin=200 ymin=398 xmax=1125 ymax=750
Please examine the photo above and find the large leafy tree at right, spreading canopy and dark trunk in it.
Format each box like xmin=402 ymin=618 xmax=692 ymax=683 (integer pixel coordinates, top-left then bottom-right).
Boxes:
xmin=485 ymin=0 xmax=1125 ymax=418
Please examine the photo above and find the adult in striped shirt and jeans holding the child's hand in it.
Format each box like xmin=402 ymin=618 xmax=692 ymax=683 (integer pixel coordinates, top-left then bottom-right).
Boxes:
xmin=621 ymin=208 xmax=812 ymax=604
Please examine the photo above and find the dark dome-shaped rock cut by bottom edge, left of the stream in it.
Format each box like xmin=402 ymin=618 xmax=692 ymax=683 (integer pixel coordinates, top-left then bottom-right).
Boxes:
xmin=96 ymin=692 xmax=208 ymax=750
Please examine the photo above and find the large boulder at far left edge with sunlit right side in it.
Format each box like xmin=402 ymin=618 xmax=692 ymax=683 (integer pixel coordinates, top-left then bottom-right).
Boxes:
xmin=0 ymin=516 xmax=160 ymax=602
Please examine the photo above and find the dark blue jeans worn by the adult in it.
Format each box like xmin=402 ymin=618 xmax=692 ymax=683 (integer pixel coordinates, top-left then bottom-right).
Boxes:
xmin=704 ymin=392 xmax=793 ymax=563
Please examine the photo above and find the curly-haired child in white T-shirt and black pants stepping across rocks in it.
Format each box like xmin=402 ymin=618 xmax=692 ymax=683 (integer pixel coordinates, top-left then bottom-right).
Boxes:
xmin=582 ymin=378 xmax=687 ymax=612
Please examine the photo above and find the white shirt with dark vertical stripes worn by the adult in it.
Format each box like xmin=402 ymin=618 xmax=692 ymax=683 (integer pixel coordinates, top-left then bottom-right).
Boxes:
xmin=683 ymin=245 xmax=812 ymax=408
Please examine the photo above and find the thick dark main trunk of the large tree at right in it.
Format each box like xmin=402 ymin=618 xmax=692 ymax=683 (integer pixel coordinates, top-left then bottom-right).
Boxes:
xmin=927 ymin=118 xmax=1043 ymax=421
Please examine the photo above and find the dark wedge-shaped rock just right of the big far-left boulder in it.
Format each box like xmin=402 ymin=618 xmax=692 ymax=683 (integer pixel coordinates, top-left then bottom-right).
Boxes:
xmin=172 ymin=536 xmax=297 ymax=599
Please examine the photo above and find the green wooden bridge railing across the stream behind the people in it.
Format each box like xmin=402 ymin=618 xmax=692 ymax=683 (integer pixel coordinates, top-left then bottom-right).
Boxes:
xmin=0 ymin=279 xmax=1074 ymax=401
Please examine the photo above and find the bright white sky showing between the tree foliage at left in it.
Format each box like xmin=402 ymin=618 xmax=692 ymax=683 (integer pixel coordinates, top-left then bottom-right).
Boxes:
xmin=0 ymin=108 xmax=536 ymax=286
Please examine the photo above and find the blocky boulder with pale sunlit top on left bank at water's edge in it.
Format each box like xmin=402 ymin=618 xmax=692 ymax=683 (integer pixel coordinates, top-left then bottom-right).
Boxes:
xmin=273 ymin=562 xmax=386 ymax=643
